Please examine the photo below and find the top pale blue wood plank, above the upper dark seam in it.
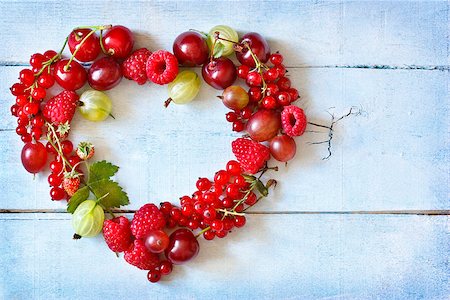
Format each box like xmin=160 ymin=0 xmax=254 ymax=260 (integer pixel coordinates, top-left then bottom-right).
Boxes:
xmin=0 ymin=1 xmax=449 ymax=66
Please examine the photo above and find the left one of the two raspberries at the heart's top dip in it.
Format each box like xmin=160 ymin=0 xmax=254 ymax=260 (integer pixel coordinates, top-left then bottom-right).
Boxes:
xmin=122 ymin=48 xmax=152 ymax=85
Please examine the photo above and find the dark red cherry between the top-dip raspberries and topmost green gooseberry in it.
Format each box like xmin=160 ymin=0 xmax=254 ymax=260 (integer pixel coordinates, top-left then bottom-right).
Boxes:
xmin=173 ymin=31 xmax=209 ymax=67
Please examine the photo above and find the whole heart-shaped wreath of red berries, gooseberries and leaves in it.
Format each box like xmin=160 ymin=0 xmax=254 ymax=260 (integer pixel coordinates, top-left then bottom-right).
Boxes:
xmin=11 ymin=25 xmax=320 ymax=282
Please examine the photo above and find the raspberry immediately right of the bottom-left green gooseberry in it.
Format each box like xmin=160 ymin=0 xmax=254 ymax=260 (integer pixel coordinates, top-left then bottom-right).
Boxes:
xmin=103 ymin=217 xmax=132 ymax=252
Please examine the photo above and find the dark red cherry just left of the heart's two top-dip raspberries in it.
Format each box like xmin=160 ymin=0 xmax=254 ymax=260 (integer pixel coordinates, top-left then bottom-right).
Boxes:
xmin=88 ymin=57 xmax=122 ymax=91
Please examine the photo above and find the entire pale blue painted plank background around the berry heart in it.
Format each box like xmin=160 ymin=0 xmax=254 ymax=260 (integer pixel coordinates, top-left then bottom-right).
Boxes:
xmin=0 ymin=1 xmax=450 ymax=299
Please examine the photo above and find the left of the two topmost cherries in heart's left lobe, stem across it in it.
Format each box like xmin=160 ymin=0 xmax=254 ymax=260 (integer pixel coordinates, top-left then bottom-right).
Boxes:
xmin=67 ymin=28 xmax=102 ymax=62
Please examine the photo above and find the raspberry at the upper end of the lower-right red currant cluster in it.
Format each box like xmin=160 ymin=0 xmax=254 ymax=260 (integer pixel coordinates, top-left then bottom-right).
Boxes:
xmin=231 ymin=138 xmax=270 ymax=174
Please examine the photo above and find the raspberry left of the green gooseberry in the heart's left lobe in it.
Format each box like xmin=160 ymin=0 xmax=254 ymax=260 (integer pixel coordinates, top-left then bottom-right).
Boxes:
xmin=43 ymin=91 xmax=80 ymax=126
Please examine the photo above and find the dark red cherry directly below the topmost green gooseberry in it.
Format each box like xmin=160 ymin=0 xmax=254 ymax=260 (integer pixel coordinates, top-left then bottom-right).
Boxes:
xmin=202 ymin=57 xmax=237 ymax=90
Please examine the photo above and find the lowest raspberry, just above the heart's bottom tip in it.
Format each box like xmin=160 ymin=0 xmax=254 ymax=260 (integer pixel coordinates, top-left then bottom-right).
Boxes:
xmin=123 ymin=240 xmax=159 ymax=270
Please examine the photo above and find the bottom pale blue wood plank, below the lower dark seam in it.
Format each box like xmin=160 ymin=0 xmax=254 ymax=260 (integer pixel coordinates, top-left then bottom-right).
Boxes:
xmin=0 ymin=215 xmax=450 ymax=299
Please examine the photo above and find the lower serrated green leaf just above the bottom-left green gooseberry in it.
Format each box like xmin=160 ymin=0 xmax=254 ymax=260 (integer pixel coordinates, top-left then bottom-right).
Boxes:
xmin=89 ymin=179 xmax=130 ymax=209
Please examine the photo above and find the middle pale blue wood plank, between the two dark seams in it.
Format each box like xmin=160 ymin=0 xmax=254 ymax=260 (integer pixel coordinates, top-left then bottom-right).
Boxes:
xmin=0 ymin=67 xmax=450 ymax=211
